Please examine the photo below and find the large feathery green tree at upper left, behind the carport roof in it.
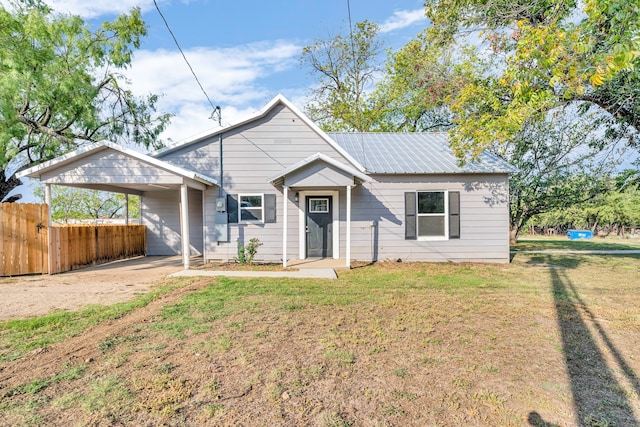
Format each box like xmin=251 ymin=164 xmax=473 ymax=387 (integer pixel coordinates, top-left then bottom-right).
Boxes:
xmin=0 ymin=0 xmax=170 ymax=200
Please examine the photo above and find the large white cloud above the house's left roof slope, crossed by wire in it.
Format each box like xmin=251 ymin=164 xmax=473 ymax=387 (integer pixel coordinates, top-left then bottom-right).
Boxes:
xmin=126 ymin=41 xmax=301 ymax=141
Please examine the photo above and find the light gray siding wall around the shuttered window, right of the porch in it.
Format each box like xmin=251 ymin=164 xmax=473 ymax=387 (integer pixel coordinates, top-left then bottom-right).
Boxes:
xmin=341 ymin=175 xmax=509 ymax=262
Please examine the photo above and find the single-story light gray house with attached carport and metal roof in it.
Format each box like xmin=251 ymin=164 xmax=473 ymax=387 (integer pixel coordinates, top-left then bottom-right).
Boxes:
xmin=20 ymin=95 xmax=515 ymax=267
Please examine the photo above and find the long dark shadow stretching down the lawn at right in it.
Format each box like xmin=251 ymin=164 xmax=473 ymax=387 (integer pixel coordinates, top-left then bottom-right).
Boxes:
xmin=529 ymin=256 xmax=640 ymax=426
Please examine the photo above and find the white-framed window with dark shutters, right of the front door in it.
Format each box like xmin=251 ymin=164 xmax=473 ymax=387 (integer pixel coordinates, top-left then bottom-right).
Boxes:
xmin=404 ymin=191 xmax=460 ymax=240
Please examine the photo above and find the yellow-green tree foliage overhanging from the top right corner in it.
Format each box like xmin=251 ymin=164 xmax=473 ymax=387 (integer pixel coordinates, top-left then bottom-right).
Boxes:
xmin=425 ymin=0 xmax=640 ymax=155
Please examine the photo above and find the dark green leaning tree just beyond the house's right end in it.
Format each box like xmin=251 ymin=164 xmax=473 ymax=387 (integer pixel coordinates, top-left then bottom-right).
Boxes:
xmin=500 ymin=111 xmax=624 ymax=243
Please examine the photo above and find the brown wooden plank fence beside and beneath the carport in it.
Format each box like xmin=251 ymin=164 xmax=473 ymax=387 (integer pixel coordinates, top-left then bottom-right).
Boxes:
xmin=0 ymin=203 xmax=146 ymax=276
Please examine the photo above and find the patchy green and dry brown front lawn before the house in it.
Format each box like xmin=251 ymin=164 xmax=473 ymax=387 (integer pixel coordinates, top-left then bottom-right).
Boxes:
xmin=0 ymin=254 xmax=640 ymax=427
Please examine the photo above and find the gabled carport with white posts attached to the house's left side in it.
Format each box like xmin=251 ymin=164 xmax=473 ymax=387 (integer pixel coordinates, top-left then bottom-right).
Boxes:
xmin=18 ymin=141 xmax=218 ymax=269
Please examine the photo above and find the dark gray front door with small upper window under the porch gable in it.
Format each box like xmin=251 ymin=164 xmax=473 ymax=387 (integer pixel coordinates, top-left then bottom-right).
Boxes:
xmin=306 ymin=196 xmax=333 ymax=258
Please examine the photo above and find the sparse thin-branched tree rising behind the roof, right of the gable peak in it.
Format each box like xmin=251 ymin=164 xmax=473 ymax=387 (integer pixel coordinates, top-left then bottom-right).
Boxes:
xmin=300 ymin=21 xmax=382 ymax=131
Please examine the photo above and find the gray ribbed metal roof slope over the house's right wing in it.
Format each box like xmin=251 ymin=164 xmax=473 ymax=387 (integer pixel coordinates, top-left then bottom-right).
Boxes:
xmin=327 ymin=132 xmax=517 ymax=174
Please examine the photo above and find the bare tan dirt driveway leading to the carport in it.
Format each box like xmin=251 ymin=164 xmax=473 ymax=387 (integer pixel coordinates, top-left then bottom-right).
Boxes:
xmin=0 ymin=257 xmax=189 ymax=320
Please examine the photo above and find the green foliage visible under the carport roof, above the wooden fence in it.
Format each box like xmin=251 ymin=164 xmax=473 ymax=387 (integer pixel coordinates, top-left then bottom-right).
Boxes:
xmin=34 ymin=185 xmax=139 ymax=224
